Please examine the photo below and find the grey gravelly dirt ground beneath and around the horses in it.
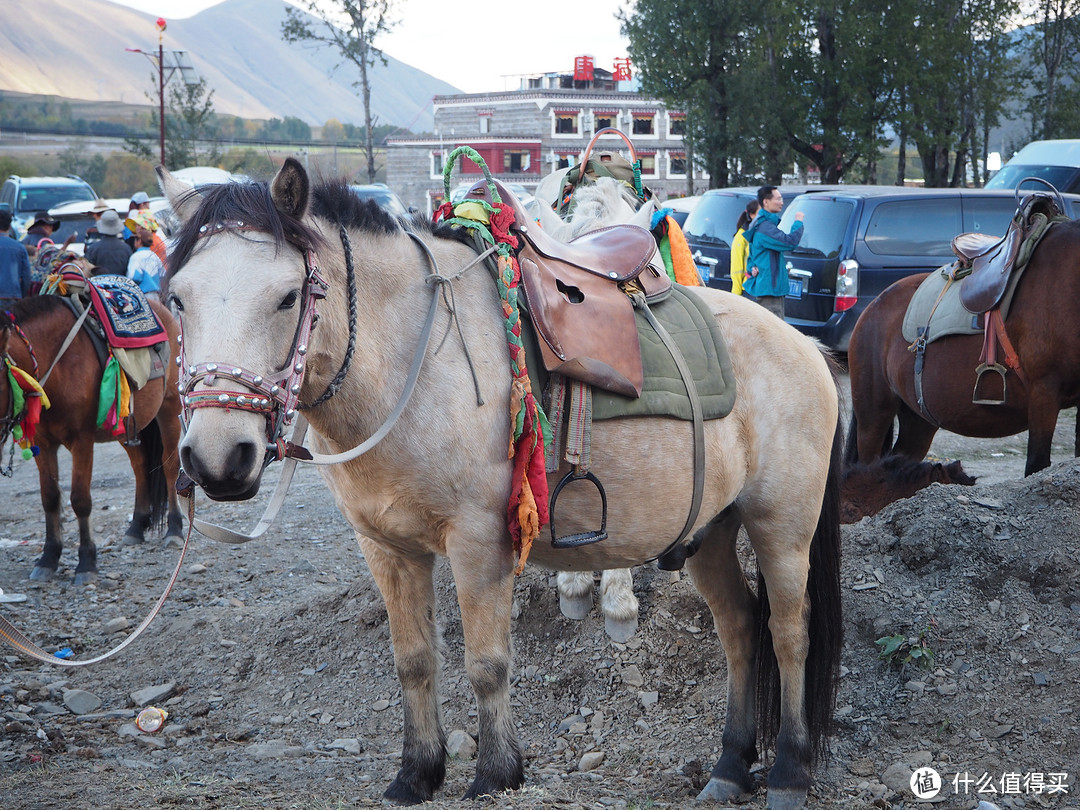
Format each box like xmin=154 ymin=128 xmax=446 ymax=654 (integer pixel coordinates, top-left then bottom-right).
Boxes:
xmin=0 ymin=384 xmax=1080 ymax=810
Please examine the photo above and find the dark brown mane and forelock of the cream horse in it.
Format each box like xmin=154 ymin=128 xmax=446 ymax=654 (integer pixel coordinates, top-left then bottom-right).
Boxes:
xmin=170 ymin=177 xmax=472 ymax=276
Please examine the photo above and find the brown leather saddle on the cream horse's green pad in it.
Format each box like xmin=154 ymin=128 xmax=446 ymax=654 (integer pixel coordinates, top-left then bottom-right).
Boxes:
xmin=464 ymin=180 xmax=671 ymax=397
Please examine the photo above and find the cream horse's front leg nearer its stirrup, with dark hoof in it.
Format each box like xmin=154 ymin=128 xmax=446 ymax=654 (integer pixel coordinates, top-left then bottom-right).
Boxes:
xmin=447 ymin=541 xmax=525 ymax=799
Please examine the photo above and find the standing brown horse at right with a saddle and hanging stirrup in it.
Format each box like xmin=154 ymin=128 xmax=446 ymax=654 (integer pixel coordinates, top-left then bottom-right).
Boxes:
xmin=847 ymin=221 xmax=1080 ymax=475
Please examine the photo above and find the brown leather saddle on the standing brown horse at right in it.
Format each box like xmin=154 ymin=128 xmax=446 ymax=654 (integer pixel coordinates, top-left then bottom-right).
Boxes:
xmin=953 ymin=194 xmax=1062 ymax=314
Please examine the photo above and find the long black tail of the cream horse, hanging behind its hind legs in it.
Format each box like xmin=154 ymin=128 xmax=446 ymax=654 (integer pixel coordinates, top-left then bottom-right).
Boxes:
xmin=757 ymin=382 xmax=843 ymax=760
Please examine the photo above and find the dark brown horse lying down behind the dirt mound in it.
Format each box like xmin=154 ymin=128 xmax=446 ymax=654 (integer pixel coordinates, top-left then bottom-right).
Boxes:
xmin=840 ymin=456 xmax=975 ymax=523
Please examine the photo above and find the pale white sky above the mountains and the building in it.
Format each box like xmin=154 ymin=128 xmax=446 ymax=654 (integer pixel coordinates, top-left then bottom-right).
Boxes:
xmin=112 ymin=0 xmax=633 ymax=93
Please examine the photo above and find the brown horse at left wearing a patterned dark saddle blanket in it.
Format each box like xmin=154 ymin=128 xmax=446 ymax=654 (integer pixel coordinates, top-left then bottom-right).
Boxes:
xmin=0 ymin=295 xmax=183 ymax=585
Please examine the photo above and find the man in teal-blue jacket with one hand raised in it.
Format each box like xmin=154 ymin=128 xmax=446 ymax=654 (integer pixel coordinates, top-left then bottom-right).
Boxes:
xmin=743 ymin=186 xmax=802 ymax=318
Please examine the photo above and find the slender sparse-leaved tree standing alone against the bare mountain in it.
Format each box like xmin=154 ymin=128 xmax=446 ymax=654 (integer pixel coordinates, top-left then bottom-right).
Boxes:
xmin=281 ymin=0 xmax=396 ymax=183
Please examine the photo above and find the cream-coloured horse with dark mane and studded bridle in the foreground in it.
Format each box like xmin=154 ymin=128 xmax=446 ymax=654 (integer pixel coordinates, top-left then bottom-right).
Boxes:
xmin=162 ymin=159 xmax=841 ymax=810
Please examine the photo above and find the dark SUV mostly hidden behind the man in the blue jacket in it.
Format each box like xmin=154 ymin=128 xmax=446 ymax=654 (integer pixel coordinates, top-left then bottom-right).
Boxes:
xmin=683 ymin=186 xmax=840 ymax=292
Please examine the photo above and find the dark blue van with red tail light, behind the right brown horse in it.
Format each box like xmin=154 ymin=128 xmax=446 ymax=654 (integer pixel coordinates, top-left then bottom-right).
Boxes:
xmin=780 ymin=186 xmax=1080 ymax=352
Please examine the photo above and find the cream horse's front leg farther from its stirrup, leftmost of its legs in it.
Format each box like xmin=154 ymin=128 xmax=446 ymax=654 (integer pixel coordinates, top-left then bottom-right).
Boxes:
xmin=356 ymin=540 xmax=446 ymax=805
